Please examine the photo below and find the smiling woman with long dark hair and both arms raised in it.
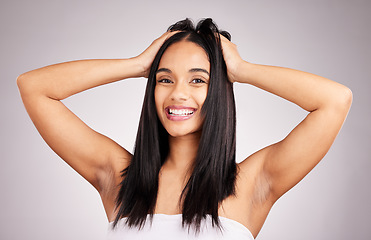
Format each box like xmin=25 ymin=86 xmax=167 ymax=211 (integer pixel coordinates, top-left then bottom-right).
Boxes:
xmin=17 ymin=19 xmax=352 ymax=239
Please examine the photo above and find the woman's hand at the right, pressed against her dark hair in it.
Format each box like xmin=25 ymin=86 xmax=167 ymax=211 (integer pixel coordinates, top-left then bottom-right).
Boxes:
xmin=220 ymin=35 xmax=245 ymax=83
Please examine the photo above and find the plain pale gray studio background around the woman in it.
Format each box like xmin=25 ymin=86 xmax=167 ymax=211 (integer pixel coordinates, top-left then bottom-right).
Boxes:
xmin=0 ymin=0 xmax=371 ymax=240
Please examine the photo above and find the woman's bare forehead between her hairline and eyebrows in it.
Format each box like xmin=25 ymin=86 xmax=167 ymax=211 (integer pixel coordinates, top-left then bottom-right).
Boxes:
xmin=158 ymin=41 xmax=210 ymax=72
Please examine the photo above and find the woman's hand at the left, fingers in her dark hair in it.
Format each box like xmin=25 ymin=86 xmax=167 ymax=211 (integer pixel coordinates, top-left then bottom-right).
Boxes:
xmin=135 ymin=31 xmax=179 ymax=78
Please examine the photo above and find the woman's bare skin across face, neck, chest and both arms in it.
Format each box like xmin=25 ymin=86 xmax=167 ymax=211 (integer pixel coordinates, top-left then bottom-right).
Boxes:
xmin=17 ymin=32 xmax=352 ymax=237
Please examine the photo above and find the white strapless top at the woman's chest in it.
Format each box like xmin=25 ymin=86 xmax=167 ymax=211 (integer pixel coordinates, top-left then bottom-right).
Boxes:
xmin=107 ymin=214 xmax=254 ymax=240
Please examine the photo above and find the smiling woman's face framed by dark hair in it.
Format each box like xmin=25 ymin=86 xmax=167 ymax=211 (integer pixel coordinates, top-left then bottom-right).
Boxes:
xmin=155 ymin=41 xmax=210 ymax=137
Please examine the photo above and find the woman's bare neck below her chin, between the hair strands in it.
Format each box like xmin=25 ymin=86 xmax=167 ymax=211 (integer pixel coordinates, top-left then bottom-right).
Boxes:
xmin=164 ymin=131 xmax=201 ymax=173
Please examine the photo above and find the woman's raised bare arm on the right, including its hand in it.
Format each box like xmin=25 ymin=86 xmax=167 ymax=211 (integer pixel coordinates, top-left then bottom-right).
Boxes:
xmin=222 ymin=35 xmax=352 ymax=201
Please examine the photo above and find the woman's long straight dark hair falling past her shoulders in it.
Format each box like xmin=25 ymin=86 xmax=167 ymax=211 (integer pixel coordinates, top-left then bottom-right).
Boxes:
xmin=113 ymin=18 xmax=237 ymax=231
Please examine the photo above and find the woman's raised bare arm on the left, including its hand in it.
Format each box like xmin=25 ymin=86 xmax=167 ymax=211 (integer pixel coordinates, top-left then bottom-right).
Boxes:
xmin=17 ymin=33 xmax=176 ymax=192
